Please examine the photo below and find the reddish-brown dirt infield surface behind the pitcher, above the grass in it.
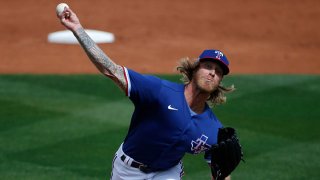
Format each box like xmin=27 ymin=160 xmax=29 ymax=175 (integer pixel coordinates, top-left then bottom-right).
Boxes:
xmin=0 ymin=0 xmax=320 ymax=74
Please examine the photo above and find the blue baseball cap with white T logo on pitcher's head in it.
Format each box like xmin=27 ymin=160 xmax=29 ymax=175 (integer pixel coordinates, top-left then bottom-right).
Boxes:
xmin=199 ymin=49 xmax=229 ymax=75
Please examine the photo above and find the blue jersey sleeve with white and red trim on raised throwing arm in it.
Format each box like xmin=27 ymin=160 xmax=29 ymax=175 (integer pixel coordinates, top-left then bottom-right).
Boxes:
xmin=124 ymin=68 xmax=161 ymax=104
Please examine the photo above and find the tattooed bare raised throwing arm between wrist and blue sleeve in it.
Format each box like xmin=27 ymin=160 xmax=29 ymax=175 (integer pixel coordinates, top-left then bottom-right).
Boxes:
xmin=73 ymin=27 xmax=127 ymax=90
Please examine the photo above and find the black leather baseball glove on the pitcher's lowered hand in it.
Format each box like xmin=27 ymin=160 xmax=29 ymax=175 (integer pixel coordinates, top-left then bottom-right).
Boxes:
xmin=211 ymin=127 xmax=243 ymax=180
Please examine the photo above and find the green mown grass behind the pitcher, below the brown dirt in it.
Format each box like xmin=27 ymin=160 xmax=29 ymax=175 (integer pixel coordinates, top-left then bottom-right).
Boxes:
xmin=0 ymin=75 xmax=320 ymax=180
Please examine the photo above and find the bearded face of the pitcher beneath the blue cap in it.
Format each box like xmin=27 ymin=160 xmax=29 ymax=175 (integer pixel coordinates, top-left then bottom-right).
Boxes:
xmin=193 ymin=60 xmax=223 ymax=93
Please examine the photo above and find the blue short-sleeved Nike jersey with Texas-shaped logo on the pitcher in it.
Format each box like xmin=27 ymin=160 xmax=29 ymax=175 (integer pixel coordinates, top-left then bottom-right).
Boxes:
xmin=123 ymin=68 xmax=222 ymax=171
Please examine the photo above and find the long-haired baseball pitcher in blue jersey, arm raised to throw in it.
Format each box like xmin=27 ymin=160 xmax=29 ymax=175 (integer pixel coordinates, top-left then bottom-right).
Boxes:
xmin=58 ymin=7 xmax=243 ymax=180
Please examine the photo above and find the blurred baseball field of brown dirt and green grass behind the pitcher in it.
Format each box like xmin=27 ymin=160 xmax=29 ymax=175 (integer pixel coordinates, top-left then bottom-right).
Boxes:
xmin=0 ymin=0 xmax=320 ymax=180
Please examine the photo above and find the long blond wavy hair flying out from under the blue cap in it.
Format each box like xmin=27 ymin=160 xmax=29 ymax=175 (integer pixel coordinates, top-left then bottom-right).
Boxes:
xmin=177 ymin=57 xmax=235 ymax=106
